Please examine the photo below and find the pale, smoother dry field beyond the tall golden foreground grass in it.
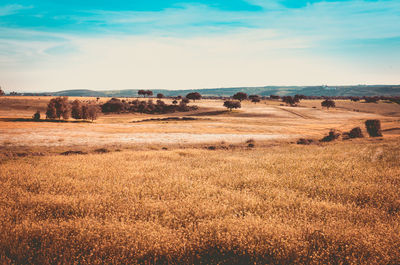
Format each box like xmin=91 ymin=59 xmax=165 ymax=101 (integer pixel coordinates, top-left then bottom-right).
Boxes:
xmin=0 ymin=97 xmax=400 ymax=147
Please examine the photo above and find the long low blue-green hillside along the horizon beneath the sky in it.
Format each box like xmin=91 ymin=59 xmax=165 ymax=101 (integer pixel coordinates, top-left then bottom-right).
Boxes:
xmin=26 ymin=85 xmax=400 ymax=97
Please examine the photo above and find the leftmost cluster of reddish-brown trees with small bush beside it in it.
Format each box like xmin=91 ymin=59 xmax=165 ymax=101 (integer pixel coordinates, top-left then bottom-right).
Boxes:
xmin=45 ymin=97 xmax=100 ymax=121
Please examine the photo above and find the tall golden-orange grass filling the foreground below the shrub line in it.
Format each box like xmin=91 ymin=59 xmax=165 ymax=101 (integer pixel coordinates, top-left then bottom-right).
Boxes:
xmin=0 ymin=138 xmax=400 ymax=264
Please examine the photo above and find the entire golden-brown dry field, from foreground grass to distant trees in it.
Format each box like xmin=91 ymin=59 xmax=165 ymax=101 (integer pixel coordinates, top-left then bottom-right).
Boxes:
xmin=0 ymin=97 xmax=400 ymax=264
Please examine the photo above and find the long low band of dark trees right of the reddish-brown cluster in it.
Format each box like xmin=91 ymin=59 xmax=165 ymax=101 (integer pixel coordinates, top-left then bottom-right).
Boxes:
xmin=101 ymin=98 xmax=198 ymax=114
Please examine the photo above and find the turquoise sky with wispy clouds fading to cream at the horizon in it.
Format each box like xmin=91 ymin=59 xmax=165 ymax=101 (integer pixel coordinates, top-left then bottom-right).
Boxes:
xmin=0 ymin=0 xmax=400 ymax=92
